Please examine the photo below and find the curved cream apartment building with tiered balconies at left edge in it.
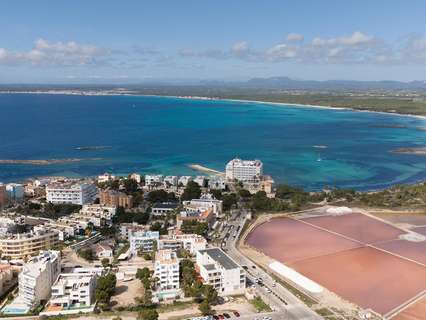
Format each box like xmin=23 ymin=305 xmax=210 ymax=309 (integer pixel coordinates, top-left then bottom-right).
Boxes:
xmin=0 ymin=226 xmax=59 ymax=260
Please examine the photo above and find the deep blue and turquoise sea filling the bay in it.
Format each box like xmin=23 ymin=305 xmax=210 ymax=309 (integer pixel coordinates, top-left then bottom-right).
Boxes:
xmin=0 ymin=94 xmax=426 ymax=190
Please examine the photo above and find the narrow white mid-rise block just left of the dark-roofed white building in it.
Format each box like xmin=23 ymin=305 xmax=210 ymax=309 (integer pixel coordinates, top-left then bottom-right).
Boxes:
xmin=154 ymin=250 xmax=179 ymax=292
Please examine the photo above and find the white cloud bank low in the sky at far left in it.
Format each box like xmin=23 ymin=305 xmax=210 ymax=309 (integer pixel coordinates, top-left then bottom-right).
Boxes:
xmin=0 ymin=39 xmax=110 ymax=65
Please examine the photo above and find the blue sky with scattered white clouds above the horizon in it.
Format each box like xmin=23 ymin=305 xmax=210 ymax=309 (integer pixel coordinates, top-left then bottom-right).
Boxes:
xmin=0 ymin=0 xmax=426 ymax=83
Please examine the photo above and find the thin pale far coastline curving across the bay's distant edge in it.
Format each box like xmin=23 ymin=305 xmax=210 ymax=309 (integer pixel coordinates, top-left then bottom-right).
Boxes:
xmin=0 ymin=90 xmax=426 ymax=122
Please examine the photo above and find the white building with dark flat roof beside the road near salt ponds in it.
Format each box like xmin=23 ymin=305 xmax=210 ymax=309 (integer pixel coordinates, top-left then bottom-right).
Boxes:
xmin=197 ymin=248 xmax=246 ymax=296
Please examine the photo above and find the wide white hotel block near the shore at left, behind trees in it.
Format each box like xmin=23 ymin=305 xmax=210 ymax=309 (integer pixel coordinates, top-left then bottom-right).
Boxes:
xmin=46 ymin=183 xmax=98 ymax=205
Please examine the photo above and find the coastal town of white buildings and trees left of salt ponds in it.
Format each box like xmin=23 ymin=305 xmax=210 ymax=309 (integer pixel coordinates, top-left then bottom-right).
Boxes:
xmin=0 ymin=159 xmax=292 ymax=320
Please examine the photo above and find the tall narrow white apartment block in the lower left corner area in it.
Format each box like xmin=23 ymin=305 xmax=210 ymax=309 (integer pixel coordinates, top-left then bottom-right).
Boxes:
xmin=12 ymin=250 xmax=61 ymax=309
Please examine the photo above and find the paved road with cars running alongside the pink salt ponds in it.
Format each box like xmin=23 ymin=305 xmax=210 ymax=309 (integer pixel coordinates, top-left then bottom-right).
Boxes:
xmin=222 ymin=210 xmax=322 ymax=320
